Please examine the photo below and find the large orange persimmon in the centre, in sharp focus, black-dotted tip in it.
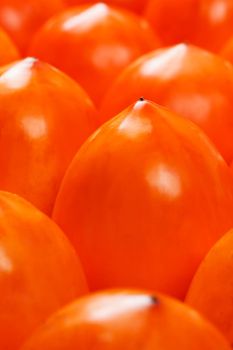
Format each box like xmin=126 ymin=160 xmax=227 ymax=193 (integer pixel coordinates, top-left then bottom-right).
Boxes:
xmin=53 ymin=101 xmax=233 ymax=297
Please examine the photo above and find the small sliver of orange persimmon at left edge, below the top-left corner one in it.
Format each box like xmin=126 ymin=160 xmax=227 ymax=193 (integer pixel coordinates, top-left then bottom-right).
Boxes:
xmin=0 ymin=29 xmax=20 ymax=66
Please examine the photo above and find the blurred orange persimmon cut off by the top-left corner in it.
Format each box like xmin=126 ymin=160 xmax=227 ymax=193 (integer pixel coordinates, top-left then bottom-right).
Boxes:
xmin=0 ymin=0 xmax=65 ymax=54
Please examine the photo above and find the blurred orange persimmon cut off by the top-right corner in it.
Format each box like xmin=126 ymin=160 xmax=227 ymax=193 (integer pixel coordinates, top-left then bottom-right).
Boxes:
xmin=145 ymin=0 xmax=233 ymax=52
